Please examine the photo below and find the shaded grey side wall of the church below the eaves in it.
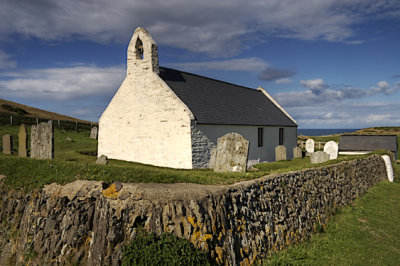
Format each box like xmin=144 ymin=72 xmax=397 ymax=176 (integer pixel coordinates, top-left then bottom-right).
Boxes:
xmin=191 ymin=123 xmax=297 ymax=168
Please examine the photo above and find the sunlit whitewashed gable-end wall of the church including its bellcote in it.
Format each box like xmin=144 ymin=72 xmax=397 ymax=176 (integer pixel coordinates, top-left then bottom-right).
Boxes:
xmin=98 ymin=28 xmax=193 ymax=169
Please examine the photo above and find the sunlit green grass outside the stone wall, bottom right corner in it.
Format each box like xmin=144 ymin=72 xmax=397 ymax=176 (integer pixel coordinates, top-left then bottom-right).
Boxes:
xmin=264 ymin=181 xmax=400 ymax=265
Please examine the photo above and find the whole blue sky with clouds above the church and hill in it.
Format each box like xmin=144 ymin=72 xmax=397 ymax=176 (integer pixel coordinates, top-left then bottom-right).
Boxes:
xmin=0 ymin=0 xmax=400 ymax=128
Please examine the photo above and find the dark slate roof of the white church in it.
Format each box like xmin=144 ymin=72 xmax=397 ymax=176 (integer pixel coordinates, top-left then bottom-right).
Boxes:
xmin=159 ymin=67 xmax=297 ymax=127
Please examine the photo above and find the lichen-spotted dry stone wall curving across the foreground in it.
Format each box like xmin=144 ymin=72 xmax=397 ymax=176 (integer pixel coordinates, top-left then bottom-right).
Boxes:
xmin=0 ymin=155 xmax=386 ymax=265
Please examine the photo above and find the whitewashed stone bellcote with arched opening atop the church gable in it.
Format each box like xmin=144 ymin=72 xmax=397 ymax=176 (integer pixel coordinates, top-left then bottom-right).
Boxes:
xmin=127 ymin=27 xmax=159 ymax=75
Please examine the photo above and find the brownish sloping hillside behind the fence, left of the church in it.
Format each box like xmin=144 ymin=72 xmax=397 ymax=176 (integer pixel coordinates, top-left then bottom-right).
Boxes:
xmin=0 ymin=99 xmax=97 ymax=124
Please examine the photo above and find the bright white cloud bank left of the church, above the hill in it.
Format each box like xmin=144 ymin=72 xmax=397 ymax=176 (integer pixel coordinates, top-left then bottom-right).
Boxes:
xmin=0 ymin=65 xmax=125 ymax=101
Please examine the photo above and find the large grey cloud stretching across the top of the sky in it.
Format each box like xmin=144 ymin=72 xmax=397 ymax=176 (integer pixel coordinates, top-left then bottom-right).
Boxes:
xmin=0 ymin=0 xmax=400 ymax=57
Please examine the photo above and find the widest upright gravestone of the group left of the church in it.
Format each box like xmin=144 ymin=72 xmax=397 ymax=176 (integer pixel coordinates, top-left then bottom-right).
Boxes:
xmin=31 ymin=121 xmax=54 ymax=159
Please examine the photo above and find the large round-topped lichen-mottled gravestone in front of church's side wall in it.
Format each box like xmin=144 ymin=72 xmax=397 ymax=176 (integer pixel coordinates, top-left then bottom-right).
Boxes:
xmin=214 ymin=132 xmax=249 ymax=172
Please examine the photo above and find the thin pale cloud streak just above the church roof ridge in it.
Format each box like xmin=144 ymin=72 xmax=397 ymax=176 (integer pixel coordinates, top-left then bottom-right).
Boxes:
xmin=169 ymin=57 xmax=268 ymax=72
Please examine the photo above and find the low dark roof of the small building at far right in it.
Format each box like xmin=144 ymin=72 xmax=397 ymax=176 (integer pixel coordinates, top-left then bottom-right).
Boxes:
xmin=339 ymin=135 xmax=397 ymax=153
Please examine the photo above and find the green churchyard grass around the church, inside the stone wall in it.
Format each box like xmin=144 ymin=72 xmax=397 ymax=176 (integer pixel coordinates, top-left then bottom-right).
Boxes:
xmin=0 ymin=126 xmax=388 ymax=191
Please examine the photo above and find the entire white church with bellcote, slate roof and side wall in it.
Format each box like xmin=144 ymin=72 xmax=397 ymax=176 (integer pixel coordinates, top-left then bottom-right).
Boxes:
xmin=98 ymin=27 xmax=297 ymax=169
